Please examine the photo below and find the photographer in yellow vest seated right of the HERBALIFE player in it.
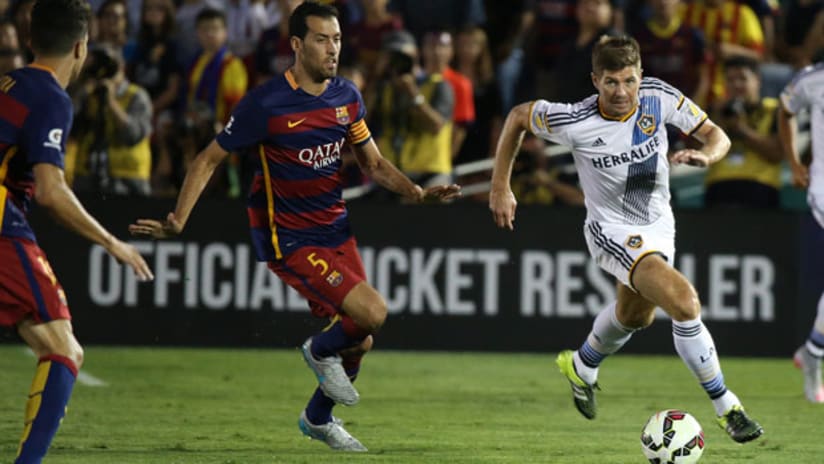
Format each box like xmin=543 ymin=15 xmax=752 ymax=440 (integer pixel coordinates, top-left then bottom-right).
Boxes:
xmin=704 ymin=56 xmax=782 ymax=208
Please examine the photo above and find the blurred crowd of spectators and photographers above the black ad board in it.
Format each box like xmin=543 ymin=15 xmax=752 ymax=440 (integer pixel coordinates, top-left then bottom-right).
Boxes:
xmin=0 ymin=0 xmax=824 ymax=208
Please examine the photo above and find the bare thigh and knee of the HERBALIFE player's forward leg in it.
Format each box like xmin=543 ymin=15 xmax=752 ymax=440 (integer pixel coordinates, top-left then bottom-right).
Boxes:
xmin=633 ymin=256 xmax=701 ymax=321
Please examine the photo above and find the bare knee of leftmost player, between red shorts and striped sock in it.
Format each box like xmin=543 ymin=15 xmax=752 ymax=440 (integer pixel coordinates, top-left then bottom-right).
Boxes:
xmin=17 ymin=319 xmax=83 ymax=369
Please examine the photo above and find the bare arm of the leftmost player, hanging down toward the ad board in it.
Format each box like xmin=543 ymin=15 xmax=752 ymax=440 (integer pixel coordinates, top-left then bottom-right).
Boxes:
xmin=33 ymin=163 xmax=154 ymax=280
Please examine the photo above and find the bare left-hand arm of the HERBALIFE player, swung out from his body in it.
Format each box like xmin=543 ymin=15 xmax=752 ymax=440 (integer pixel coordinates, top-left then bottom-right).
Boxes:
xmin=489 ymin=102 xmax=533 ymax=230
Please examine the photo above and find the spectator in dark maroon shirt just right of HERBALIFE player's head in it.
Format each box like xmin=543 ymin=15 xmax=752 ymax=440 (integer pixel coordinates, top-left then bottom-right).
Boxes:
xmin=634 ymin=0 xmax=710 ymax=106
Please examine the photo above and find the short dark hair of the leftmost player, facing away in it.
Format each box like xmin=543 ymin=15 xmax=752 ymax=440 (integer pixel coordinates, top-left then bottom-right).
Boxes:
xmin=30 ymin=0 xmax=92 ymax=56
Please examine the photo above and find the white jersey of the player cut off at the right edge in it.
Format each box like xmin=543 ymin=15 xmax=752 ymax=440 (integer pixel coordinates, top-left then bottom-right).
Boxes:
xmin=781 ymin=63 xmax=824 ymax=199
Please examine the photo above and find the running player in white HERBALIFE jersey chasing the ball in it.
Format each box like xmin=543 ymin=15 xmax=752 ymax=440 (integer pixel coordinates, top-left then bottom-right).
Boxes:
xmin=489 ymin=36 xmax=763 ymax=442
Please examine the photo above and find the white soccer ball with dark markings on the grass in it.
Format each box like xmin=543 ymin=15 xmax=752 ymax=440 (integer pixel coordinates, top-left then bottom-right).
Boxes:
xmin=641 ymin=409 xmax=704 ymax=464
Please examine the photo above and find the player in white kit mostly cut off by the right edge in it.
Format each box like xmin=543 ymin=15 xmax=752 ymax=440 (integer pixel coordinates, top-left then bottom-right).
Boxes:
xmin=778 ymin=63 xmax=824 ymax=403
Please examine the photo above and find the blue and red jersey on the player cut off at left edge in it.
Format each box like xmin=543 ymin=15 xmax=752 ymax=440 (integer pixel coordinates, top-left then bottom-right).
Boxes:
xmin=0 ymin=65 xmax=73 ymax=245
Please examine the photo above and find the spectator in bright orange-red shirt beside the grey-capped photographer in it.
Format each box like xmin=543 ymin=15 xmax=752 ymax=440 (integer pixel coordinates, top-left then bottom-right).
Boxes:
xmin=422 ymin=31 xmax=475 ymax=159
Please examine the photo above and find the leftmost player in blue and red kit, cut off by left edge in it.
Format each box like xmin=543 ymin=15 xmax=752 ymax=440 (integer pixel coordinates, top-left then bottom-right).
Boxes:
xmin=0 ymin=0 xmax=152 ymax=464
